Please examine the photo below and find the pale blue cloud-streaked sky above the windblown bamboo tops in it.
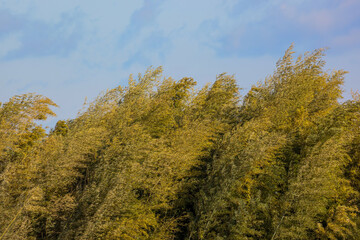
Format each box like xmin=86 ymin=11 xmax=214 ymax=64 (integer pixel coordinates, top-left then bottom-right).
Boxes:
xmin=0 ymin=0 xmax=360 ymax=127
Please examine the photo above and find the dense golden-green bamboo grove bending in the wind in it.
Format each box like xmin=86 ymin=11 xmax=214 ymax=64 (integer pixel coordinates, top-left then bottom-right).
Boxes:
xmin=0 ymin=47 xmax=360 ymax=240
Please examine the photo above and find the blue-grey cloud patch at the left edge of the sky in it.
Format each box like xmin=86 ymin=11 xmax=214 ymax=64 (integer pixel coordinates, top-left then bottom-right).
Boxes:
xmin=0 ymin=8 xmax=83 ymax=61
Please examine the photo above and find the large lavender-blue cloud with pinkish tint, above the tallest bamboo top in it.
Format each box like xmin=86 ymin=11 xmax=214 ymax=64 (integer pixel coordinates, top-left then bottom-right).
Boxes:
xmin=198 ymin=0 xmax=360 ymax=57
